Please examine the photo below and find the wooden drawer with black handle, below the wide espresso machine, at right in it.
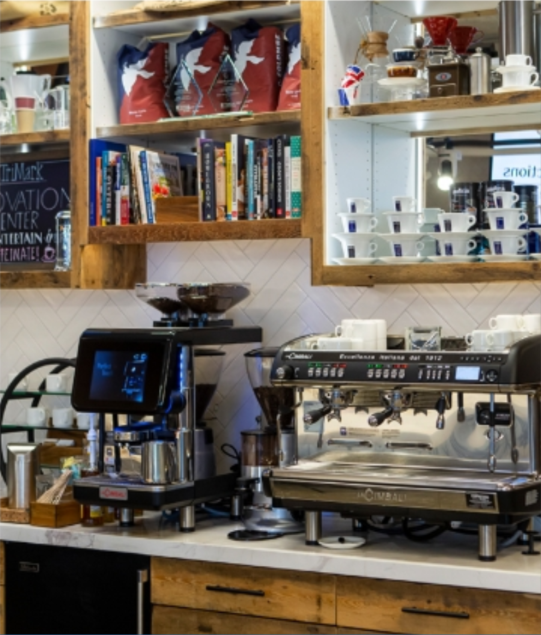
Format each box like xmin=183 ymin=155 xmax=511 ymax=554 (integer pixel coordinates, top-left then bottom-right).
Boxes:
xmin=336 ymin=577 xmax=541 ymax=635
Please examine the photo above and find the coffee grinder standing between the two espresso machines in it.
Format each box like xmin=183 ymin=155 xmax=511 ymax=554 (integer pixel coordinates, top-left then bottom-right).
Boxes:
xmin=231 ymin=347 xmax=304 ymax=539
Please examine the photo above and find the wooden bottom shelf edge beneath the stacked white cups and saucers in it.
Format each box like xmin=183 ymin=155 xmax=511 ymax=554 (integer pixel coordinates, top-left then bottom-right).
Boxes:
xmin=321 ymin=261 xmax=541 ymax=287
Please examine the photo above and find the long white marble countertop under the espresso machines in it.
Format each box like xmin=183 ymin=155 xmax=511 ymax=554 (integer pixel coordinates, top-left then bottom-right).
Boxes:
xmin=0 ymin=513 xmax=541 ymax=594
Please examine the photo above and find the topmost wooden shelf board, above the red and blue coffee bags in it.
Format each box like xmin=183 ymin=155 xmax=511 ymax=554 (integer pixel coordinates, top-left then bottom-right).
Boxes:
xmin=93 ymin=0 xmax=299 ymax=35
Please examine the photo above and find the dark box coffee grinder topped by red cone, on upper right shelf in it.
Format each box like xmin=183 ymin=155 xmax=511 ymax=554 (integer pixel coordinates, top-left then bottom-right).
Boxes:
xmin=423 ymin=16 xmax=470 ymax=97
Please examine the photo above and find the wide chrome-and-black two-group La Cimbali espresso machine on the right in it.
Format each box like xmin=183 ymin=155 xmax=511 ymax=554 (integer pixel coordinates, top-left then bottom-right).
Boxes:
xmin=263 ymin=335 xmax=541 ymax=561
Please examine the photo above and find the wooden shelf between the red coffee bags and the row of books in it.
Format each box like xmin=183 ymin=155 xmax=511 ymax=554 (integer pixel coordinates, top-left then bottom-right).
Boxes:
xmin=96 ymin=110 xmax=301 ymax=143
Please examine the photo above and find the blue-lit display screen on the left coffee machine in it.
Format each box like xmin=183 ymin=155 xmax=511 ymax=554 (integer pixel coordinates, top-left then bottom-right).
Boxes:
xmin=90 ymin=351 xmax=148 ymax=403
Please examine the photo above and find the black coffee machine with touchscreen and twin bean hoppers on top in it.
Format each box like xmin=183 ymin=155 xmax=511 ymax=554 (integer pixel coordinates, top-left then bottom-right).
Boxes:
xmin=72 ymin=283 xmax=262 ymax=531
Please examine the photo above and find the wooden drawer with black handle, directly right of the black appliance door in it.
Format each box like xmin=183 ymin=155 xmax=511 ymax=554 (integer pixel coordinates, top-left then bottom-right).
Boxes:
xmin=151 ymin=558 xmax=336 ymax=625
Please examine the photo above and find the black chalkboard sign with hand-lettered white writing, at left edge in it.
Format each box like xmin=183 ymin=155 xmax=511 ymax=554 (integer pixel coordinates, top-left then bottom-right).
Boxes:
xmin=0 ymin=160 xmax=70 ymax=269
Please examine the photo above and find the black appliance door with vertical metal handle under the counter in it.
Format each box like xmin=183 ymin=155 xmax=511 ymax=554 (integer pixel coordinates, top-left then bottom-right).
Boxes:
xmin=5 ymin=542 xmax=150 ymax=635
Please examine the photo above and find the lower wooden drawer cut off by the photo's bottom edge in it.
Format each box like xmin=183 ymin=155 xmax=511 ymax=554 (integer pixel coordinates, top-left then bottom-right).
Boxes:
xmin=152 ymin=606 xmax=336 ymax=635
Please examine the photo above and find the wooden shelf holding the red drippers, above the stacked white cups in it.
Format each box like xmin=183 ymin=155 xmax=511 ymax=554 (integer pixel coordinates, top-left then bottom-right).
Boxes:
xmin=328 ymin=90 xmax=541 ymax=137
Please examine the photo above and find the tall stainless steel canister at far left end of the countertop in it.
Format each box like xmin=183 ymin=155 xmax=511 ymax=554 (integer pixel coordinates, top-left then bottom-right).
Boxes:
xmin=7 ymin=443 xmax=39 ymax=509
